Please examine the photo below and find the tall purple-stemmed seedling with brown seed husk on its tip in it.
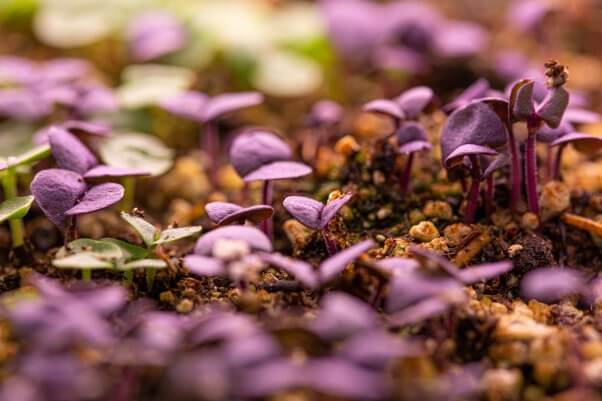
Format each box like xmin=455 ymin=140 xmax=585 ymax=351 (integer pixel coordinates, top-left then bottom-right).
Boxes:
xmin=510 ymin=61 xmax=569 ymax=215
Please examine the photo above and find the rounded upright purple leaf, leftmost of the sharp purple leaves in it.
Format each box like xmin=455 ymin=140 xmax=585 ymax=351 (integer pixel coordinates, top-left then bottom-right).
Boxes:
xmin=31 ymin=169 xmax=86 ymax=230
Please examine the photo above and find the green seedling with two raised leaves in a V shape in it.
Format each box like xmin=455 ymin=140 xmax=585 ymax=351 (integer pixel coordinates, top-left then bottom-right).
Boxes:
xmin=121 ymin=212 xmax=203 ymax=288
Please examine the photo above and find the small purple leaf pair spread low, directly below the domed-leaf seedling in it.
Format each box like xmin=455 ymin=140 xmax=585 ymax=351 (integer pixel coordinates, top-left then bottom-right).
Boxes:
xmin=205 ymin=202 xmax=274 ymax=226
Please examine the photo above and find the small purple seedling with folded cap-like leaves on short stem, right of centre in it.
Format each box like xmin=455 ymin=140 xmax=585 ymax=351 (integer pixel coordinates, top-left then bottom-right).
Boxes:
xmin=397 ymin=122 xmax=433 ymax=193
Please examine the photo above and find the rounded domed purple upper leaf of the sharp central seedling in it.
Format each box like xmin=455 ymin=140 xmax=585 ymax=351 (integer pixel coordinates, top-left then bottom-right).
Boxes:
xmin=229 ymin=129 xmax=292 ymax=177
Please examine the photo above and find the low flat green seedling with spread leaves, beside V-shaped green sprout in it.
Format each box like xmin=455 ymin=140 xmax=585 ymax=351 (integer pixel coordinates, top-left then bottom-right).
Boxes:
xmin=52 ymin=238 xmax=167 ymax=282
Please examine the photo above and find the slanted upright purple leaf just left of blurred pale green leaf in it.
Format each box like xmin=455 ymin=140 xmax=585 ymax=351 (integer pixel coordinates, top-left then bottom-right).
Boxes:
xmin=48 ymin=127 xmax=98 ymax=174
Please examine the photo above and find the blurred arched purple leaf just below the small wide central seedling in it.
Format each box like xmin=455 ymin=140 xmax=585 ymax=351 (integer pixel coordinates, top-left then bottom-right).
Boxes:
xmin=194 ymin=225 xmax=272 ymax=256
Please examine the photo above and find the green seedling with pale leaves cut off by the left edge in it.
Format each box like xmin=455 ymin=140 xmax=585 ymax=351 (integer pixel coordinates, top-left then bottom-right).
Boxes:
xmin=0 ymin=145 xmax=51 ymax=248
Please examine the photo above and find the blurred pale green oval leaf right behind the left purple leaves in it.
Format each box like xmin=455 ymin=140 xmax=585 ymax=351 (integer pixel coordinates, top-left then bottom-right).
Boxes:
xmin=99 ymin=133 xmax=174 ymax=176
